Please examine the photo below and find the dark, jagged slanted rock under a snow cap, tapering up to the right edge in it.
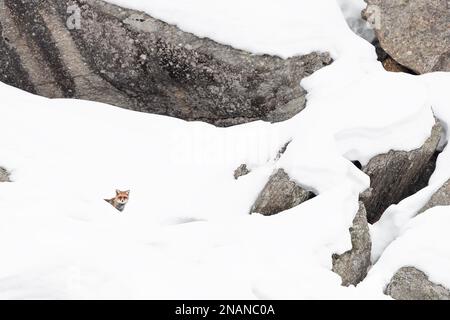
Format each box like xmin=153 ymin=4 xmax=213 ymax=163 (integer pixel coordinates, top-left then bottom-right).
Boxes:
xmin=361 ymin=123 xmax=442 ymax=223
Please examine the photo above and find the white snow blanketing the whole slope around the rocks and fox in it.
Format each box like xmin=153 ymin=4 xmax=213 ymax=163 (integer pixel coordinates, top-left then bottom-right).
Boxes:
xmin=0 ymin=0 xmax=450 ymax=299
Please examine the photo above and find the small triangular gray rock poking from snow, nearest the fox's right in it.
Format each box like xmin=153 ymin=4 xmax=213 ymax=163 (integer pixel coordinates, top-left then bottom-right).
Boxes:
xmin=250 ymin=169 xmax=314 ymax=216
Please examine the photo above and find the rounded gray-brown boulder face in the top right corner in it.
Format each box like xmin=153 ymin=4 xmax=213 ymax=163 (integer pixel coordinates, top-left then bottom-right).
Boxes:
xmin=363 ymin=0 xmax=450 ymax=74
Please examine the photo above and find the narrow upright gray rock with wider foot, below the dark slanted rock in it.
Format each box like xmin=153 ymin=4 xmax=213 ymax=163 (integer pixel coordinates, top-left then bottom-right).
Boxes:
xmin=332 ymin=201 xmax=372 ymax=286
